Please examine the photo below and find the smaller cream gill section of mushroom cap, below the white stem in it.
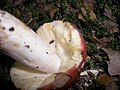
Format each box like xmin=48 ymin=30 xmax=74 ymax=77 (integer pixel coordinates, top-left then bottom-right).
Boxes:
xmin=10 ymin=62 xmax=52 ymax=90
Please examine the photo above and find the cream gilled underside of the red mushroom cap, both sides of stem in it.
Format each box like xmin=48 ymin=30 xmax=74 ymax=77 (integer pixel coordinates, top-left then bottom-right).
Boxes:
xmin=10 ymin=21 xmax=83 ymax=90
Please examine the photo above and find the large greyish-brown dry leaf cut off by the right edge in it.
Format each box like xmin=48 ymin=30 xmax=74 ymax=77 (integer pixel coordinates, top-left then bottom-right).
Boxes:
xmin=102 ymin=48 xmax=120 ymax=76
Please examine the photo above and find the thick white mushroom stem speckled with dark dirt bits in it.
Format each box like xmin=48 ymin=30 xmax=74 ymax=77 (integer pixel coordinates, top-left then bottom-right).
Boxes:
xmin=0 ymin=10 xmax=61 ymax=73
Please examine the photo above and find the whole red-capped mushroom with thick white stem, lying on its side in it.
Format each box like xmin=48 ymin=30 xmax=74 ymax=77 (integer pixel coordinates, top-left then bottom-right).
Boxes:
xmin=0 ymin=10 xmax=86 ymax=90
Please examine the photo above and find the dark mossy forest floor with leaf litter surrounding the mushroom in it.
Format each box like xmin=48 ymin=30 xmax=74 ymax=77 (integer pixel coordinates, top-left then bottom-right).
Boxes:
xmin=0 ymin=0 xmax=120 ymax=90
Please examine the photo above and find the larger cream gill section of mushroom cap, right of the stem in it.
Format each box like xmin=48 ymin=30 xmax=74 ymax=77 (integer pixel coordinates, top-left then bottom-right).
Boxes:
xmin=37 ymin=21 xmax=82 ymax=71
